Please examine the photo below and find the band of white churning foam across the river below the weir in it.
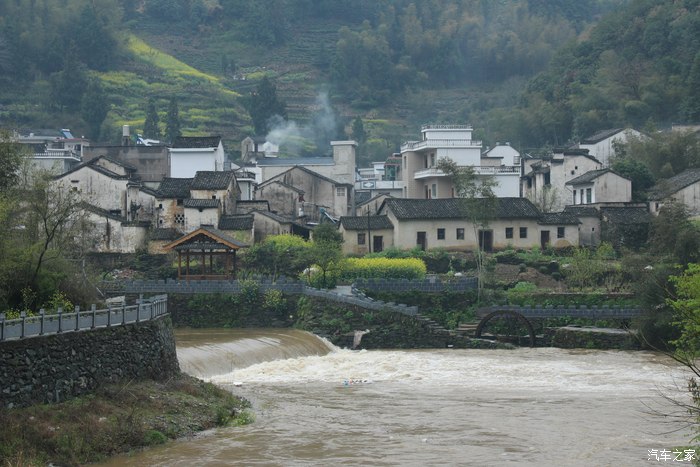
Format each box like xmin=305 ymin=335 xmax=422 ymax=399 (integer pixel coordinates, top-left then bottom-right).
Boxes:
xmin=212 ymin=348 xmax=680 ymax=393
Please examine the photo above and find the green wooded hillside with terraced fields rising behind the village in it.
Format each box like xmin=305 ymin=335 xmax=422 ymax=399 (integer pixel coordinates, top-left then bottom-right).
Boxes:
xmin=0 ymin=0 xmax=700 ymax=163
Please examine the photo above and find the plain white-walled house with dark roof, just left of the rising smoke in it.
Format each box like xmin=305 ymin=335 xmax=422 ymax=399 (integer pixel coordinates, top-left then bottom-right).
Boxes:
xmin=169 ymin=136 xmax=225 ymax=178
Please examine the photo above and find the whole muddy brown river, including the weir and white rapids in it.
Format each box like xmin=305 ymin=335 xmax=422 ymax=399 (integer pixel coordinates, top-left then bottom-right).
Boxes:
xmin=103 ymin=329 xmax=691 ymax=466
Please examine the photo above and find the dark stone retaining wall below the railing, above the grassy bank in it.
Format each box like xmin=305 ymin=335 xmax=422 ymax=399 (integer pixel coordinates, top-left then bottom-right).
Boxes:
xmin=0 ymin=316 xmax=180 ymax=407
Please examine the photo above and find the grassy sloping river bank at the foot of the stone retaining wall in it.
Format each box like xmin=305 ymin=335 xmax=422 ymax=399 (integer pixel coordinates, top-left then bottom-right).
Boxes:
xmin=0 ymin=374 xmax=252 ymax=467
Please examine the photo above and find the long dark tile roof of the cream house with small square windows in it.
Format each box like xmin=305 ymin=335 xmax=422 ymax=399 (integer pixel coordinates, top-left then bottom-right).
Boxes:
xmin=384 ymin=198 xmax=540 ymax=220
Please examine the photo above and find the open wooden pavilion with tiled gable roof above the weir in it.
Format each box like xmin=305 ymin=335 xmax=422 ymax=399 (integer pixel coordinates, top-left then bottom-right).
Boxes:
xmin=163 ymin=226 xmax=248 ymax=280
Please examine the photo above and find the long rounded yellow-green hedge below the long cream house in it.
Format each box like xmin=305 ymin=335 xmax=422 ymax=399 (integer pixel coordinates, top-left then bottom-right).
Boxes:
xmin=341 ymin=258 xmax=427 ymax=280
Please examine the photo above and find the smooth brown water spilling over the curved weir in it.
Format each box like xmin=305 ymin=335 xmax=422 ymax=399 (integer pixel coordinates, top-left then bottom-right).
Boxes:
xmin=175 ymin=329 xmax=336 ymax=379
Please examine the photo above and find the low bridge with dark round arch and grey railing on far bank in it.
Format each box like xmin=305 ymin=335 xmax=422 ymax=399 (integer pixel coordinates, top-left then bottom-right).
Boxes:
xmin=474 ymin=305 xmax=643 ymax=347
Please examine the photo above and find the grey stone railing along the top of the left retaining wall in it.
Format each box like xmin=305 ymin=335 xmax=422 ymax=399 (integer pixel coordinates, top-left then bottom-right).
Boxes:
xmin=0 ymin=295 xmax=168 ymax=342
